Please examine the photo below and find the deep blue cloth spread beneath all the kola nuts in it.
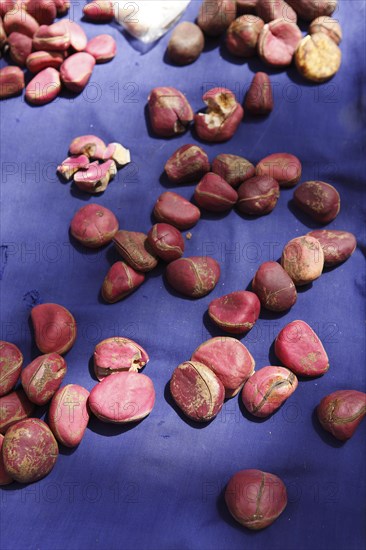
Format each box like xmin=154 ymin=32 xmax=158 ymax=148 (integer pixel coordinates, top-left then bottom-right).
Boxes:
xmin=0 ymin=0 xmax=366 ymax=550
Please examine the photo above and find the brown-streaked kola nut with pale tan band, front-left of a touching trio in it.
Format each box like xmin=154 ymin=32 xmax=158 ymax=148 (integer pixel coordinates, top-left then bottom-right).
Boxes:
xmin=170 ymin=361 xmax=225 ymax=422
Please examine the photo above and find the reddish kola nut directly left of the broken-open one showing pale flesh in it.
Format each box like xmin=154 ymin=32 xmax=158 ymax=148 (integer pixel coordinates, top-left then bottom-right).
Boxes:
xmin=148 ymin=87 xmax=194 ymax=137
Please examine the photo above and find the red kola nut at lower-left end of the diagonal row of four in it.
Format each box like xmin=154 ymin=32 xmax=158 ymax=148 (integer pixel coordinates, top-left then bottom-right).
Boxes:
xmin=208 ymin=290 xmax=261 ymax=334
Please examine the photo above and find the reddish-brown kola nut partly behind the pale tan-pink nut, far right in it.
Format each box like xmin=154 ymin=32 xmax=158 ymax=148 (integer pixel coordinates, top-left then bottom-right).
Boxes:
xmin=308 ymin=229 xmax=357 ymax=267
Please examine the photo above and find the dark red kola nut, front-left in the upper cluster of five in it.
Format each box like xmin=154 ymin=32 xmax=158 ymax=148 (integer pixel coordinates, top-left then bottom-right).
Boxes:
xmin=194 ymin=172 xmax=238 ymax=212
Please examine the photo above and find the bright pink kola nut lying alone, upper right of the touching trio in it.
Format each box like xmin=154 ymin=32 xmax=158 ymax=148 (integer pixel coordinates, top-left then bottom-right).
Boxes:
xmin=275 ymin=321 xmax=329 ymax=376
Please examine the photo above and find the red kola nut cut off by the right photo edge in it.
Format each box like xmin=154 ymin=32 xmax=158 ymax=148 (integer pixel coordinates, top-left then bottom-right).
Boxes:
xmin=317 ymin=390 xmax=366 ymax=441
